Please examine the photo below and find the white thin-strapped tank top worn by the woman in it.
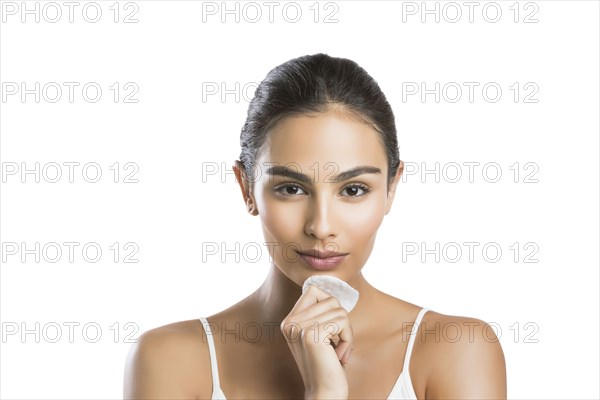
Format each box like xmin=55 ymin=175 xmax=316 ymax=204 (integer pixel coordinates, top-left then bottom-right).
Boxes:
xmin=199 ymin=308 xmax=429 ymax=400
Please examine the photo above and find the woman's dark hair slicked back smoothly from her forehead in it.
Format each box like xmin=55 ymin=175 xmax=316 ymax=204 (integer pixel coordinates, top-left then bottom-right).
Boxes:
xmin=240 ymin=53 xmax=400 ymax=189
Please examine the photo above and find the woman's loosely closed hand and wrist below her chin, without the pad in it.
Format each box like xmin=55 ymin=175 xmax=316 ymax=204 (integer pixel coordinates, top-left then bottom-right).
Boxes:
xmin=280 ymin=285 xmax=353 ymax=399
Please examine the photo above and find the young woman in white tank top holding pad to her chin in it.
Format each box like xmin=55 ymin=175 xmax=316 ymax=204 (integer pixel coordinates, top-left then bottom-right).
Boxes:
xmin=124 ymin=54 xmax=506 ymax=399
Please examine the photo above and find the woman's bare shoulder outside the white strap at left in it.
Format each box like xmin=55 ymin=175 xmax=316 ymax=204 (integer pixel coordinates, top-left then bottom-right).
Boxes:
xmin=123 ymin=320 xmax=212 ymax=399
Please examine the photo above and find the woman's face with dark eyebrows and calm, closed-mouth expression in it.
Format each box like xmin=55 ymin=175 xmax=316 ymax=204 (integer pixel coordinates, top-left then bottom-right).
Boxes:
xmin=241 ymin=111 xmax=402 ymax=286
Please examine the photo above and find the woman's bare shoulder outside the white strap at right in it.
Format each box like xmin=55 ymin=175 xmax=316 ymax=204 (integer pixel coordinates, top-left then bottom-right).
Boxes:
xmin=415 ymin=311 xmax=507 ymax=399
